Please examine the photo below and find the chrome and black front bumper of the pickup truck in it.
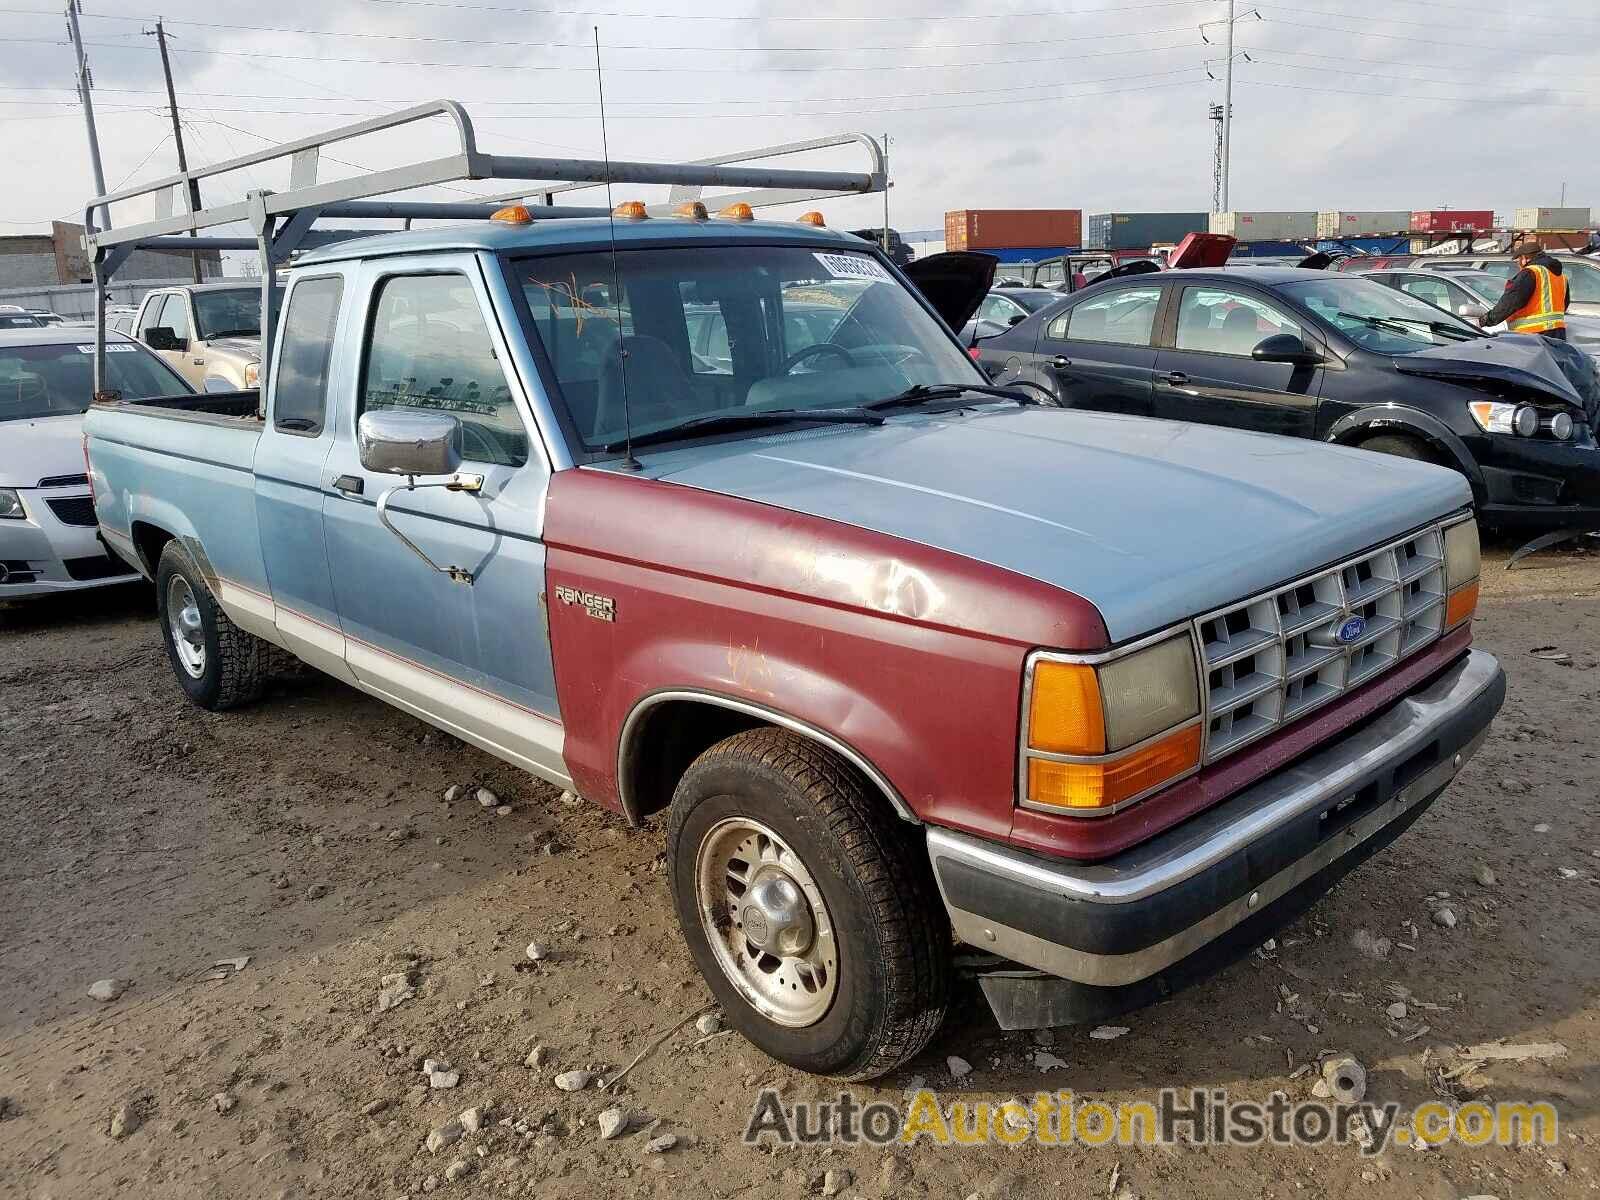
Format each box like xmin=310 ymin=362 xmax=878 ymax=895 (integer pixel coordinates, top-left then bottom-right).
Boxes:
xmin=928 ymin=650 xmax=1506 ymax=1029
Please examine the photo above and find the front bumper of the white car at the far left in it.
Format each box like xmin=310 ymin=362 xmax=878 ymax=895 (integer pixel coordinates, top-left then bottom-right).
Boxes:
xmin=0 ymin=485 xmax=139 ymax=600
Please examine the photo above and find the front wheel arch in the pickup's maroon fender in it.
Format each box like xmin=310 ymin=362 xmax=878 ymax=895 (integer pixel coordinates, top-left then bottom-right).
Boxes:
xmin=616 ymin=688 xmax=922 ymax=826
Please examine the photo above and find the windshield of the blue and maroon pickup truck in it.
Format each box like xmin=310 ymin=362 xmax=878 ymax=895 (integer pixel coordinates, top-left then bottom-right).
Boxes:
xmin=510 ymin=246 xmax=987 ymax=453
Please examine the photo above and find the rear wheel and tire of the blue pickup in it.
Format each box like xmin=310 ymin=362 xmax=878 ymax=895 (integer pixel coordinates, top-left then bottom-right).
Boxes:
xmin=155 ymin=539 xmax=275 ymax=712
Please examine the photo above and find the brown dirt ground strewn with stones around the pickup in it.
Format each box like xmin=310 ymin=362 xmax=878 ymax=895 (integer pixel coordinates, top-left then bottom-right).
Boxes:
xmin=0 ymin=552 xmax=1600 ymax=1200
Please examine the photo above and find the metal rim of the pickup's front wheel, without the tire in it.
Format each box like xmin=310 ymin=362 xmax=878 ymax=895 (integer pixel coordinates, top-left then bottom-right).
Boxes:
xmin=694 ymin=816 xmax=838 ymax=1029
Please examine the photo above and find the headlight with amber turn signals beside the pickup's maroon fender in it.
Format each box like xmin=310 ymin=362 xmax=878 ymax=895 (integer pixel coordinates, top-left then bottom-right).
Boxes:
xmin=1021 ymin=634 xmax=1202 ymax=816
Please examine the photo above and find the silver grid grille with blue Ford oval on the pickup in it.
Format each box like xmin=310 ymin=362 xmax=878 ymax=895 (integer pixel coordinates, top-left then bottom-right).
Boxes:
xmin=1195 ymin=525 xmax=1445 ymax=762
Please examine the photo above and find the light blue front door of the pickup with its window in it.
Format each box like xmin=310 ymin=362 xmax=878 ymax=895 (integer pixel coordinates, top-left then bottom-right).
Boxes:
xmin=322 ymin=254 xmax=565 ymax=779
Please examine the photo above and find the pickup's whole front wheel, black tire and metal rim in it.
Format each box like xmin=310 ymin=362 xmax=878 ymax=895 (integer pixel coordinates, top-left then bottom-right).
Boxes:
xmin=667 ymin=726 xmax=950 ymax=1080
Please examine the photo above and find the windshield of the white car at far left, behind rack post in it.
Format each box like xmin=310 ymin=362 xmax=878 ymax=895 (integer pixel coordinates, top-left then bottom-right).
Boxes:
xmin=0 ymin=341 xmax=192 ymax=421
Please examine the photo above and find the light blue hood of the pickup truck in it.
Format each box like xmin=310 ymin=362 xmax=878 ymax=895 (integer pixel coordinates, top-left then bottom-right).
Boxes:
xmin=645 ymin=406 xmax=1472 ymax=642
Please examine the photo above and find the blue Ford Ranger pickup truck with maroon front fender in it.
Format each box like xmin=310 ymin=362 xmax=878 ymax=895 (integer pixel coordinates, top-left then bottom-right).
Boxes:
xmin=86 ymin=206 xmax=1504 ymax=1078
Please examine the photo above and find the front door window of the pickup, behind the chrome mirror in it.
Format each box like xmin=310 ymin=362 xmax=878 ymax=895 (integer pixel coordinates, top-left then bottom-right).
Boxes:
xmin=360 ymin=274 xmax=528 ymax=467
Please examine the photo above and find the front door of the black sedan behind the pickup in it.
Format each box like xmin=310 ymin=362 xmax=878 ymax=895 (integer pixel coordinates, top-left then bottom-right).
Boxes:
xmin=1155 ymin=283 xmax=1322 ymax=437
